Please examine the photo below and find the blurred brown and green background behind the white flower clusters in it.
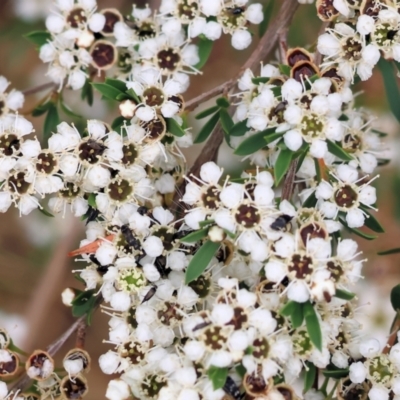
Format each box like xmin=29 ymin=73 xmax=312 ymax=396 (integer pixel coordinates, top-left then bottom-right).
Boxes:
xmin=0 ymin=0 xmax=400 ymax=400
